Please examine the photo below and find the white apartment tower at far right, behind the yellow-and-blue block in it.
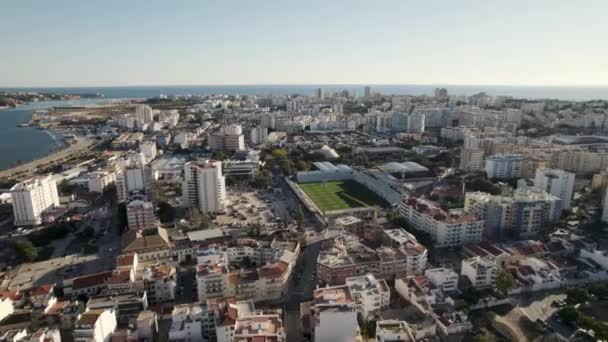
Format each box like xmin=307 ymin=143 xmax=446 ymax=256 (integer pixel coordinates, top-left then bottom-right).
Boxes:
xmin=534 ymin=169 xmax=575 ymax=210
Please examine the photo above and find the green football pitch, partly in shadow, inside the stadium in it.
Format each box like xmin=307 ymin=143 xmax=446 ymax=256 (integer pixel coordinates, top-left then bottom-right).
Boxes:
xmin=299 ymin=180 xmax=386 ymax=211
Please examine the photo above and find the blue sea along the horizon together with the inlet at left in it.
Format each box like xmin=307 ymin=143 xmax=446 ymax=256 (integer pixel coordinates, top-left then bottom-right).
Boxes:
xmin=0 ymin=84 xmax=608 ymax=170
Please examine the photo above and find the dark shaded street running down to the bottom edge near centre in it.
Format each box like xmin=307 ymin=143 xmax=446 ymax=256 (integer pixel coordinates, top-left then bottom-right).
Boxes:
xmin=284 ymin=242 xmax=321 ymax=342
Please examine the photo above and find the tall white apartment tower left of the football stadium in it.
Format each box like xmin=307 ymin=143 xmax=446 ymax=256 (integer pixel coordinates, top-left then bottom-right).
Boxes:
xmin=182 ymin=160 xmax=226 ymax=213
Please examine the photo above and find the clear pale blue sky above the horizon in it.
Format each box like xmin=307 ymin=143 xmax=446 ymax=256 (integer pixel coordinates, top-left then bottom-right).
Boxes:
xmin=0 ymin=0 xmax=608 ymax=86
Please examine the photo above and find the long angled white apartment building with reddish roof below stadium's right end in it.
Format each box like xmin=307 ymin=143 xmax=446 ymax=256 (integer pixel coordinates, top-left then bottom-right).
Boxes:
xmin=399 ymin=197 xmax=484 ymax=247
